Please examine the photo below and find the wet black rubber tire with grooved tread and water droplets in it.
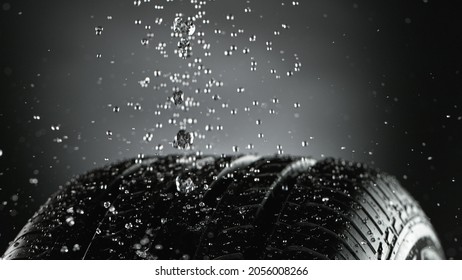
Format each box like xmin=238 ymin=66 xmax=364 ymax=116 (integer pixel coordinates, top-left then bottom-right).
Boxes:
xmin=3 ymin=155 xmax=444 ymax=259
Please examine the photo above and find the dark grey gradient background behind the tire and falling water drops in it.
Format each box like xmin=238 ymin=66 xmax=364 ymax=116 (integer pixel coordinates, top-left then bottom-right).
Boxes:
xmin=0 ymin=0 xmax=462 ymax=259
